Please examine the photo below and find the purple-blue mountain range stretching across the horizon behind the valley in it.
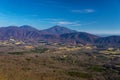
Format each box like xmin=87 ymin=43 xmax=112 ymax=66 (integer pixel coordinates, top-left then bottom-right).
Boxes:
xmin=0 ymin=25 xmax=120 ymax=47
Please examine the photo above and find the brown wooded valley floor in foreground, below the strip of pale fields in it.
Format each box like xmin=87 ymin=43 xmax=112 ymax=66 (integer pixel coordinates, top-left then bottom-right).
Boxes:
xmin=0 ymin=48 xmax=120 ymax=80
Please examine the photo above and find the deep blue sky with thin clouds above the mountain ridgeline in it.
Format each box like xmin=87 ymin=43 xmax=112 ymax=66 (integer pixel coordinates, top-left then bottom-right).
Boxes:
xmin=0 ymin=0 xmax=120 ymax=34
